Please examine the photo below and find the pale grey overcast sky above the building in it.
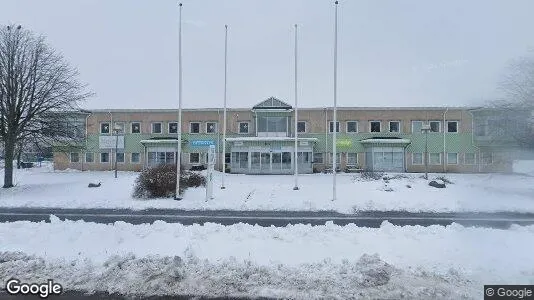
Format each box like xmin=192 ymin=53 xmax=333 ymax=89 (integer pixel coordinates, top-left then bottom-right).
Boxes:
xmin=0 ymin=0 xmax=534 ymax=108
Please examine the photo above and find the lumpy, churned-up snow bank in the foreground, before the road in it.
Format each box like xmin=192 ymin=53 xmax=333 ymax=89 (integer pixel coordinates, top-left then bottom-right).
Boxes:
xmin=0 ymin=216 xmax=534 ymax=299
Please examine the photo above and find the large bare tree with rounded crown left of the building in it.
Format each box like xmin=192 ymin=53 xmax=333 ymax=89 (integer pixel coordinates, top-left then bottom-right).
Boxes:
xmin=0 ymin=26 xmax=90 ymax=188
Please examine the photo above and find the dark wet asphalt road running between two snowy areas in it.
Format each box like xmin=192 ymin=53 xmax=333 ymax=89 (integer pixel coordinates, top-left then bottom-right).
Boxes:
xmin=0 ymin=208 xmax=534 ymax=229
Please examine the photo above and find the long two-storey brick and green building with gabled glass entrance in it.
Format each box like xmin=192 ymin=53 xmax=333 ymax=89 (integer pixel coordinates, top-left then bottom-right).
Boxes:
xmin=54 ymin=97 xmax=528 ymax=174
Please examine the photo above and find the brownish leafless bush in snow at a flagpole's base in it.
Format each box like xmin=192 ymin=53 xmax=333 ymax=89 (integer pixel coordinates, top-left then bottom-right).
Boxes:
xmin=133 ymin=165 xmax=206 ymax=198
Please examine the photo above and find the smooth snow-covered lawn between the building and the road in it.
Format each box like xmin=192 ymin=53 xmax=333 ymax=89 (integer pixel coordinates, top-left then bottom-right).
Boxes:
xmin=0 ymin=161 xmax=534 ymax=213
